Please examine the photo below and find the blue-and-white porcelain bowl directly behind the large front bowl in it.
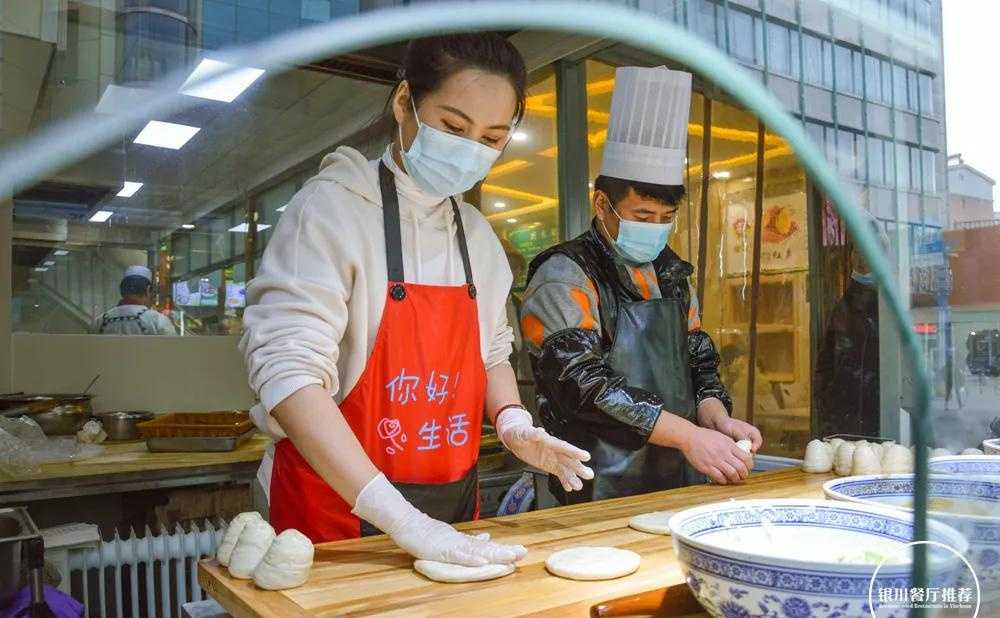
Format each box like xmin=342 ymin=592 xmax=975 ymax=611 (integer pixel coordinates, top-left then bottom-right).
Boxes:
xmin=823 ymin=474 xmax=1000 ymax=601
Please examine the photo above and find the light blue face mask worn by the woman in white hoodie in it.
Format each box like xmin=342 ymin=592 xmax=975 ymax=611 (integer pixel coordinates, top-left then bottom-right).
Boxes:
xmin=399 ymin=99 xmax=500 ymax=199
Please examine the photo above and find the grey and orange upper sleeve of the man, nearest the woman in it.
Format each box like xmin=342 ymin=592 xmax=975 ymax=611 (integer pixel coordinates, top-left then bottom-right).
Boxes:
xmin=521 ymin=255 xmax=601 ymax=352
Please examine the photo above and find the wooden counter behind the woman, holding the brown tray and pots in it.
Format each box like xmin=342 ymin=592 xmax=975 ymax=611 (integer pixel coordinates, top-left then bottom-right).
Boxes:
xmin=0 ymin=434 xmax=270 ymax=504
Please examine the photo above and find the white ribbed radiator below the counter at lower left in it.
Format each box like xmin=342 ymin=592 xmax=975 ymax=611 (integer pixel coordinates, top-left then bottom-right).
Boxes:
xmin=68 ymin=520 xmax=226 ymax=618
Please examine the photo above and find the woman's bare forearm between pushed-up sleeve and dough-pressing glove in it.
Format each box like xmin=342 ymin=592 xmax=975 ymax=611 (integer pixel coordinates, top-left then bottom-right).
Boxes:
xmin=271 ymin=385 xmax=379 ymax=507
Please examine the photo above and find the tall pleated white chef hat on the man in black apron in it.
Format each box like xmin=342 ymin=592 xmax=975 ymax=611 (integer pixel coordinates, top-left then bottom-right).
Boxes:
xmin=601 ymin=66 xmax=691 ymax=185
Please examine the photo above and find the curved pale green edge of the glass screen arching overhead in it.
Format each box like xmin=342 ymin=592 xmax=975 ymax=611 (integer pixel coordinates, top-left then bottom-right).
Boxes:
xmin=0 ymin=1 xmax=931 ymax=586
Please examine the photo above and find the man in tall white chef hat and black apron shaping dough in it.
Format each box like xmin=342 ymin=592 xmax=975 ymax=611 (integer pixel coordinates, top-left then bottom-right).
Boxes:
xmin=521 ymin=67 xmax=762 ymax=504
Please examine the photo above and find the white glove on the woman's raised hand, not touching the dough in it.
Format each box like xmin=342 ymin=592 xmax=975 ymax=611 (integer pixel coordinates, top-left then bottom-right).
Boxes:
xmin=494 ymin=408 xmax=594 ymax=491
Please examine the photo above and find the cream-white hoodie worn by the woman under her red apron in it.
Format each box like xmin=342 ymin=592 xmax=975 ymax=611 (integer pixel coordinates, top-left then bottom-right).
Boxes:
xmin=240 ymin=146 xmax=513 ymax=490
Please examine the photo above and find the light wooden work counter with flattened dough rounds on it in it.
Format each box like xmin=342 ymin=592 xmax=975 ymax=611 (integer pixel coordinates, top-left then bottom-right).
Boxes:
xmin=198 ymin=469 xmax=832 ymax=618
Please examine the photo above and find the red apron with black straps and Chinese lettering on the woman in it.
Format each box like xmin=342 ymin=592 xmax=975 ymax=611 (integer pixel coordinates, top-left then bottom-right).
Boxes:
xmin=270 ymin=164 xmax=486 ymax=543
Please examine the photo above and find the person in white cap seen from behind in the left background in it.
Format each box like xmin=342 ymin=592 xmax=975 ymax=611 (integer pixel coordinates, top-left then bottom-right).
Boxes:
xmin=93 ymin=265 xmax=177 ymax=335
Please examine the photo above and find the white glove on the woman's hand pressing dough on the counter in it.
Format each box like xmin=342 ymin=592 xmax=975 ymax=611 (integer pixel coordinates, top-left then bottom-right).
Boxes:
xmin=351 ymin=473 xmax=528 ymax=566
